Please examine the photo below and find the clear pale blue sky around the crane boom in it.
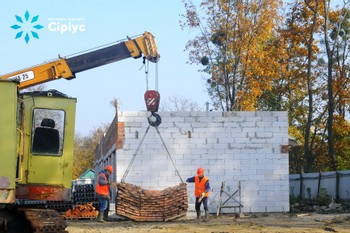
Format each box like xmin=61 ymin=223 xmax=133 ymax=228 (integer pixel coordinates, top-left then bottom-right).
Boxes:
xmin=0 ymin=0 xmax=209 ymax=135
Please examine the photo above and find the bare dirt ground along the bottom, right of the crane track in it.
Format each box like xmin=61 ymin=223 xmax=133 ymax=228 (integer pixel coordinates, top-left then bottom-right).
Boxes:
xmin=66 ymin=213 xmax=350 ymax=233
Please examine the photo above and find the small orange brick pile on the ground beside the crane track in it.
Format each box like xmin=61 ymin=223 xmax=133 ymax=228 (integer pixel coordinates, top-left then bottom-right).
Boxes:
xmin=63 ymin=203 xmax=98 ymax=219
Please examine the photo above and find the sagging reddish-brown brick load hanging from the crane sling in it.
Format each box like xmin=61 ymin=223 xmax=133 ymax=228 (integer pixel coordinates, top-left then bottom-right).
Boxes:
xmin=115 ymin=183 xmax=188 ymax=222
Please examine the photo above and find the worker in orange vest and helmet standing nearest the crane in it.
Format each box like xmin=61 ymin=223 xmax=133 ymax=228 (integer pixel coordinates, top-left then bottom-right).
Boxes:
xmin=95 ymin=165 xmax=116 ymax=222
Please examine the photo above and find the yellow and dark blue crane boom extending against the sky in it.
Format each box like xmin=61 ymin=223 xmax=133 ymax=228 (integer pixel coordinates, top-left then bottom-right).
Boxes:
xmin=0 ymin=32 xmax=160 ymax=89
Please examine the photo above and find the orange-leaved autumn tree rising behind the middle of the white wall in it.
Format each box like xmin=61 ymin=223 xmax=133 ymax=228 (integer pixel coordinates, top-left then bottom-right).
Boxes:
xmin=181 ymin=0 xmax=284 ymax=111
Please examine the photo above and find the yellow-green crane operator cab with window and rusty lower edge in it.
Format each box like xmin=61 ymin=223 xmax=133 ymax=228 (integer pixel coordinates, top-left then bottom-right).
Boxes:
xmin=16 ymin=90 xmax=76 ymax=201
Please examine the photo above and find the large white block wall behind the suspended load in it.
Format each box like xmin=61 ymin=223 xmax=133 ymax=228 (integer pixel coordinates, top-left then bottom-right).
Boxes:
xmin=116 ymin=112 xmax=289 ymax=213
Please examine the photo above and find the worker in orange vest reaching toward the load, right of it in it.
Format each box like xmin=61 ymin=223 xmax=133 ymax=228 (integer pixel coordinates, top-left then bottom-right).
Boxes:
xmin=186 ymin=167 xmax=210 ymax=221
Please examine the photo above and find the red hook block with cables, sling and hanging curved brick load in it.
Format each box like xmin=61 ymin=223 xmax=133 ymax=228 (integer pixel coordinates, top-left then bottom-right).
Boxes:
xmin=115 ymin=54 xmax=188 ymax=221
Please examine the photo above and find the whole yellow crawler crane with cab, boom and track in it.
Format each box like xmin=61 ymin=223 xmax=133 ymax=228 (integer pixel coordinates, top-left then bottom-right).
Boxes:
xmin=0 ymin=32 xmax=160 ymax=232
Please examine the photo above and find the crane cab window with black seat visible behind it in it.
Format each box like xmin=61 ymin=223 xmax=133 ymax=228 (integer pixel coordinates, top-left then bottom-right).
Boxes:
xmin=32 ymin=108 xmax=65 ymax=156
